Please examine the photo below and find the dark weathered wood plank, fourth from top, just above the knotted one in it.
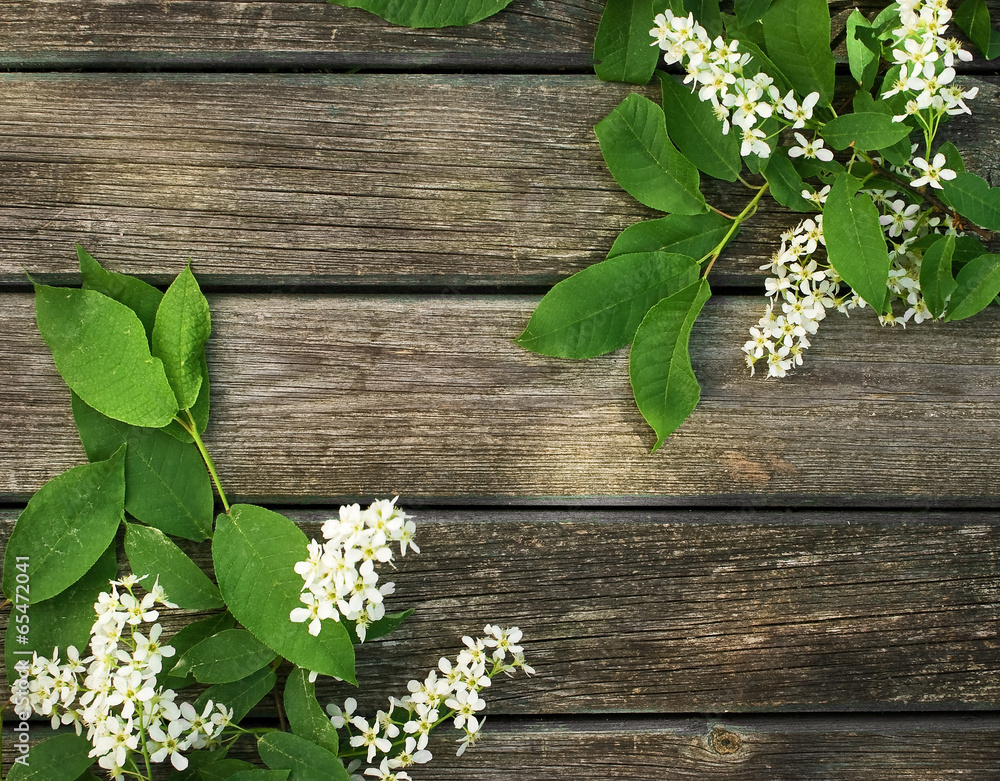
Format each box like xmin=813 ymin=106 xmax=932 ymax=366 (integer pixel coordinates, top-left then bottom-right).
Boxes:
xmin=0 ymin=512 xmax=1000 ymax=715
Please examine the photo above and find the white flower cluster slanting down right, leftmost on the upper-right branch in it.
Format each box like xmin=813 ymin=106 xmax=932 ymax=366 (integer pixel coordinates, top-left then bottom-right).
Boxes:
xmin=649 ymin=9 xmax=833 ymax=160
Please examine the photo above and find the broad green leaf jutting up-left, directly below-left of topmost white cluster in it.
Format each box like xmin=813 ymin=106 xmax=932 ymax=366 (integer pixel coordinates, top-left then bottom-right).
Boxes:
xmin=594 ymin=94 xmax=708 ymax=214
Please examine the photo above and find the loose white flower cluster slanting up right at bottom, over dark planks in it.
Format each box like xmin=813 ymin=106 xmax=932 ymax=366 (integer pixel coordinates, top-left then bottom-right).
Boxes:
xmin=327 ymin=624 xmax=535 ymax=781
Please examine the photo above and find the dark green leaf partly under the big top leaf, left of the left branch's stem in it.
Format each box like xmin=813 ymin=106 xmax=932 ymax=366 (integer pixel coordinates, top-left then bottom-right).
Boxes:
xmin=72 ymin=394 xmax=215 ymax=541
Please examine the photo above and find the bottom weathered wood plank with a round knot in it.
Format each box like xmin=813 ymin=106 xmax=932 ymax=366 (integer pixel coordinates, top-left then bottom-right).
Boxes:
xmin=3 ymin=716 xmax=1000 ymax=781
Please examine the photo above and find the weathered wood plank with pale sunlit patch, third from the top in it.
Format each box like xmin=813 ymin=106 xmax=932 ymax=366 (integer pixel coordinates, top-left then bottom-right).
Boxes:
xmin=0 ymin=294 xmax=1000 ymax=507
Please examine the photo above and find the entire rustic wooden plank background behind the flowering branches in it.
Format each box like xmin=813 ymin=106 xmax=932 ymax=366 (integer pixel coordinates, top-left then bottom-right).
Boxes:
xmin=0 ymin=0 xmax=1000 ymax=781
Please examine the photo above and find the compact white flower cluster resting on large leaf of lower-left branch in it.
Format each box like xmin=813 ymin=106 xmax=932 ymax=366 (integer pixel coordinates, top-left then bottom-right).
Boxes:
xmin=289 ymin=497 xmax=420 ymax=642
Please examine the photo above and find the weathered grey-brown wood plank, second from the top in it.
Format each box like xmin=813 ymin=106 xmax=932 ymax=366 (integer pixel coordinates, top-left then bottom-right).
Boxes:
xmin=0 ymin=75 xmax=1000 ymax=288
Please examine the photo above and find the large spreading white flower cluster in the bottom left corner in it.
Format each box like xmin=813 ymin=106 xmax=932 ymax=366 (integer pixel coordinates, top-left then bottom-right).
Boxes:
xmin=10 ymin=576 xmax=232 ymax=781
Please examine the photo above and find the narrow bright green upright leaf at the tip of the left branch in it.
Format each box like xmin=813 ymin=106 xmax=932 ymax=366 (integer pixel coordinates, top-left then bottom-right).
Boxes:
xmin=153 ymin=265 xmax=212 ymax=410
